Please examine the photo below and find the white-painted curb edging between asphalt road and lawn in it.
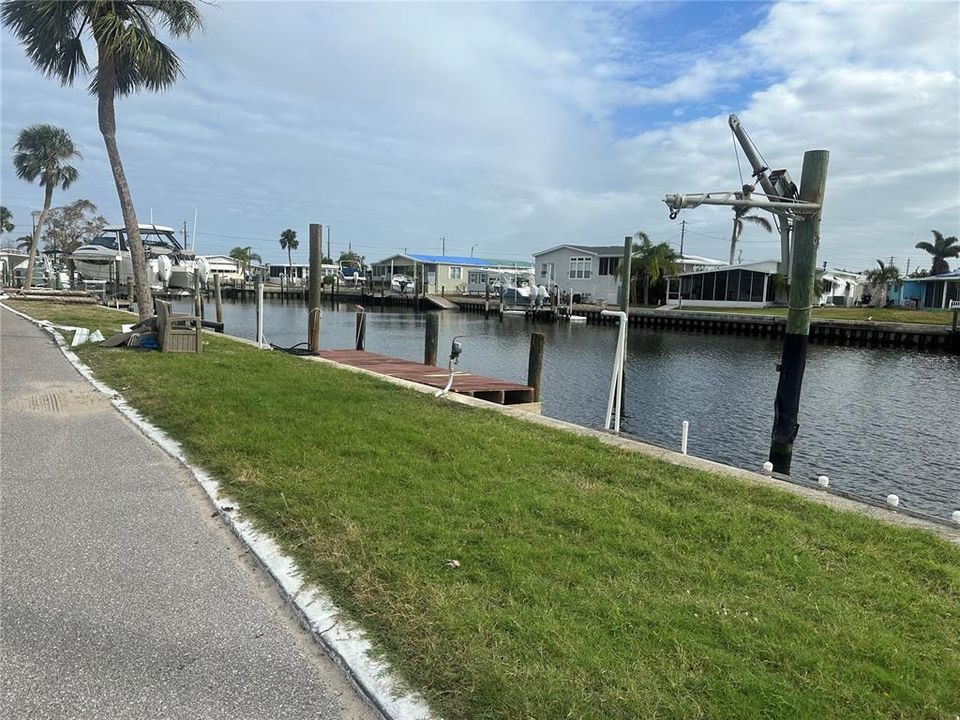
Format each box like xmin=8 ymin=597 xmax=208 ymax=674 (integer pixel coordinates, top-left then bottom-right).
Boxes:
xmin=0 ymin=303 xmax=439 ymax=720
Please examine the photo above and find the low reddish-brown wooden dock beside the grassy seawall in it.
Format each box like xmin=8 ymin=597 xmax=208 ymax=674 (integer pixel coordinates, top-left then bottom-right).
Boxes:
xmin=319 ymin=350 xmax=539 ymax=412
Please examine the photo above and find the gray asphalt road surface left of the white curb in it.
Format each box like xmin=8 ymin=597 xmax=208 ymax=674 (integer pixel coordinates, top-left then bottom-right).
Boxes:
xmin=0 ymin=310 xmax=375 ymax=720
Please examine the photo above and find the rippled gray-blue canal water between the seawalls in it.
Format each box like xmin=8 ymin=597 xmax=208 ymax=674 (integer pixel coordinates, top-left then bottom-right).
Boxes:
xmin=195 ymin=302 xmax=960 ymax=517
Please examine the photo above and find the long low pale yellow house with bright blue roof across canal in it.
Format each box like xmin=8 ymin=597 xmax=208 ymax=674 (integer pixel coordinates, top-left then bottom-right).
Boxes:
xmin=371 ymin=253 xmax=533 ymax=294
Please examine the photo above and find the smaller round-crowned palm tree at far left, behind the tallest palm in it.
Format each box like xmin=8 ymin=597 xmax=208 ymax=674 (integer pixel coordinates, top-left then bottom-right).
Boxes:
xmin=13 ymin=125 xmax=81 ymax=290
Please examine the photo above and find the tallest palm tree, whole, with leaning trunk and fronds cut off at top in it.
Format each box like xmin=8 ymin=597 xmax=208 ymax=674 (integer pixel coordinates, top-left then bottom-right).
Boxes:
xmin=0 ymin=0 xmax=202 ymax=318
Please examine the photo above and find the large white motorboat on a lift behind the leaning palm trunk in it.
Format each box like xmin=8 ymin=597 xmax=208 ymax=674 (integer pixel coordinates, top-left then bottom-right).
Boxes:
xmin=70 ymin=225 xmax=209 ymax=289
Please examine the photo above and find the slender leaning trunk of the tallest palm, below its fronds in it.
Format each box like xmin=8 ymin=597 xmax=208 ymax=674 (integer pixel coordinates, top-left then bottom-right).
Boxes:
xmin=97 ymin=48 xmax=153 ymax=320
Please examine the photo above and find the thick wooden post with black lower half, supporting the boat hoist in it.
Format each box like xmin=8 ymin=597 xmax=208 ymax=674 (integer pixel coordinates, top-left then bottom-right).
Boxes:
xmin=769 ymin=150 xmax=830 ymax=475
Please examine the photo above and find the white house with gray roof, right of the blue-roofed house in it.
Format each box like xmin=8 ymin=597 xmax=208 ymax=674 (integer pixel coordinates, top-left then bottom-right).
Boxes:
xmin=533 ymin=244 xmax=623 ymax=304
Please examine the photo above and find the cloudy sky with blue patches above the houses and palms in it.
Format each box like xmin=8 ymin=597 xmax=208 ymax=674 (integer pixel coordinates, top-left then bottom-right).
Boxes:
xmin=0 ymin=0 xmax=960 ymax=270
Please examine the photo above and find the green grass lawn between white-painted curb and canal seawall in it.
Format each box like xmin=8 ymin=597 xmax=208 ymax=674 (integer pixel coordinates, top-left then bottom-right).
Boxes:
xmin=3 ymin=303 xmax=960 ymax=720
